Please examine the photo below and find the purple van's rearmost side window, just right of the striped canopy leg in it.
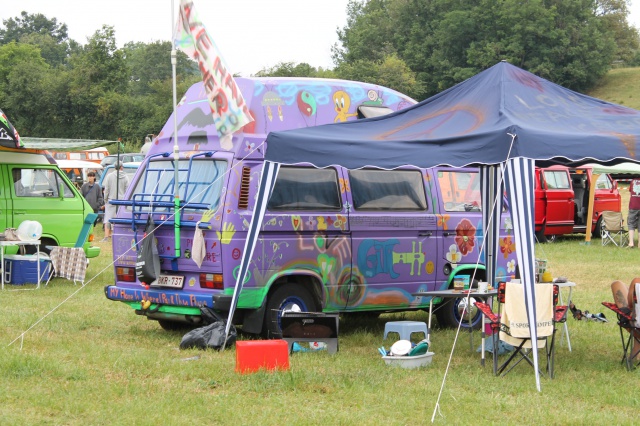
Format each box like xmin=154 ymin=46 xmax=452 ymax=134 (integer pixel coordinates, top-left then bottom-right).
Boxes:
xmin=267 ymin=167 xmax=341 ymax=211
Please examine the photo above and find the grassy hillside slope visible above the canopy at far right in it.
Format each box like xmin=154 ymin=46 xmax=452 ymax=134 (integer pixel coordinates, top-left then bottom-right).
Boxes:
xmin=588 ymin=67 xmax=640 ymax=109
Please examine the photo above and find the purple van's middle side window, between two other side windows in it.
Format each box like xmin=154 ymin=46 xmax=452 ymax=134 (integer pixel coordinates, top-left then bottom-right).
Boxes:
xmin=349 ymin=170 xmax=427 ymax=211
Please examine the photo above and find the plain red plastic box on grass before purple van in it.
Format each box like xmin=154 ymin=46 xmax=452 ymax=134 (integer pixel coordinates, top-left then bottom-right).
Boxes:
xmin=236 ymin=340 xmax=289 ymax=373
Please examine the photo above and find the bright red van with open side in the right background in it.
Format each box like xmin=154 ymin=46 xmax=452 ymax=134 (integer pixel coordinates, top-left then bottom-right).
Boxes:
xmin=535 ymin=166 xmax=621 ymax=242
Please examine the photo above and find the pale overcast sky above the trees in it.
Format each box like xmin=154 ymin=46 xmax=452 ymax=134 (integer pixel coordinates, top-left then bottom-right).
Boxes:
xmin=0 ymin=0 xmax=640 ymax=77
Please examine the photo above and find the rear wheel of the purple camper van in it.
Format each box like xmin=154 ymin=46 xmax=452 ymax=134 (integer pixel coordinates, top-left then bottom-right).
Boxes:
xmin=262 ymin=284 xmax=317 ymax=339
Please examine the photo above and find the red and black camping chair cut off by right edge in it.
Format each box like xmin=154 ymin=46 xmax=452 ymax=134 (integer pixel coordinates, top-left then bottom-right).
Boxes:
xmin=602 ymin=283 xmax=640 ymax=371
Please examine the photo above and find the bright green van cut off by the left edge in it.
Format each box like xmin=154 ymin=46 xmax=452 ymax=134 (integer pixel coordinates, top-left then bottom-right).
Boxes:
xmin=0 ymin=148 xmax=100 ymax=258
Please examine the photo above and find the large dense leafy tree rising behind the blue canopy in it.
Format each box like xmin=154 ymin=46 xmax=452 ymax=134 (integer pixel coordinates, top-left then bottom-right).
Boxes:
xmin=333 ymin=0 xmax=637 ymax=97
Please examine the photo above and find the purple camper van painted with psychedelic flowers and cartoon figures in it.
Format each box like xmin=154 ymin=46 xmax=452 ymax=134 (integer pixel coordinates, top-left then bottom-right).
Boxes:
xmin=105 ymin=78 xmax=515 ymax=337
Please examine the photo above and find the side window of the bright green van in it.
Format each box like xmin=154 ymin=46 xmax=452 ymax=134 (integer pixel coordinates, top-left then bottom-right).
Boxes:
xmin=11 ymin=169 xmax=74 ymax=198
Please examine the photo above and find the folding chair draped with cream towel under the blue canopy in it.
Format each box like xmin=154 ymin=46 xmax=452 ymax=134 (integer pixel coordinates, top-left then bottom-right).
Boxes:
xmin=476 ymin=282 xmax=567 ymax=378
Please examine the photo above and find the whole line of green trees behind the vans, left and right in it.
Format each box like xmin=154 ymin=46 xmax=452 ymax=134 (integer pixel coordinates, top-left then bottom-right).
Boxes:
xmin=0 ymin=0 xmax=640 ymax=143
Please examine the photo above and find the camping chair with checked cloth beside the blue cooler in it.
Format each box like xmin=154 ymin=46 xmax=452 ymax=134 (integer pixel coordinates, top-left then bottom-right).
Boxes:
xmin=45 ymin=213 xmax=98 ymax=286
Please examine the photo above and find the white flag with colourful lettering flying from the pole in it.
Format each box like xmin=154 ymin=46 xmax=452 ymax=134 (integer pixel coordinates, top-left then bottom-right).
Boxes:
xmin=174 ymin=0 xmax=253 ymax=149
